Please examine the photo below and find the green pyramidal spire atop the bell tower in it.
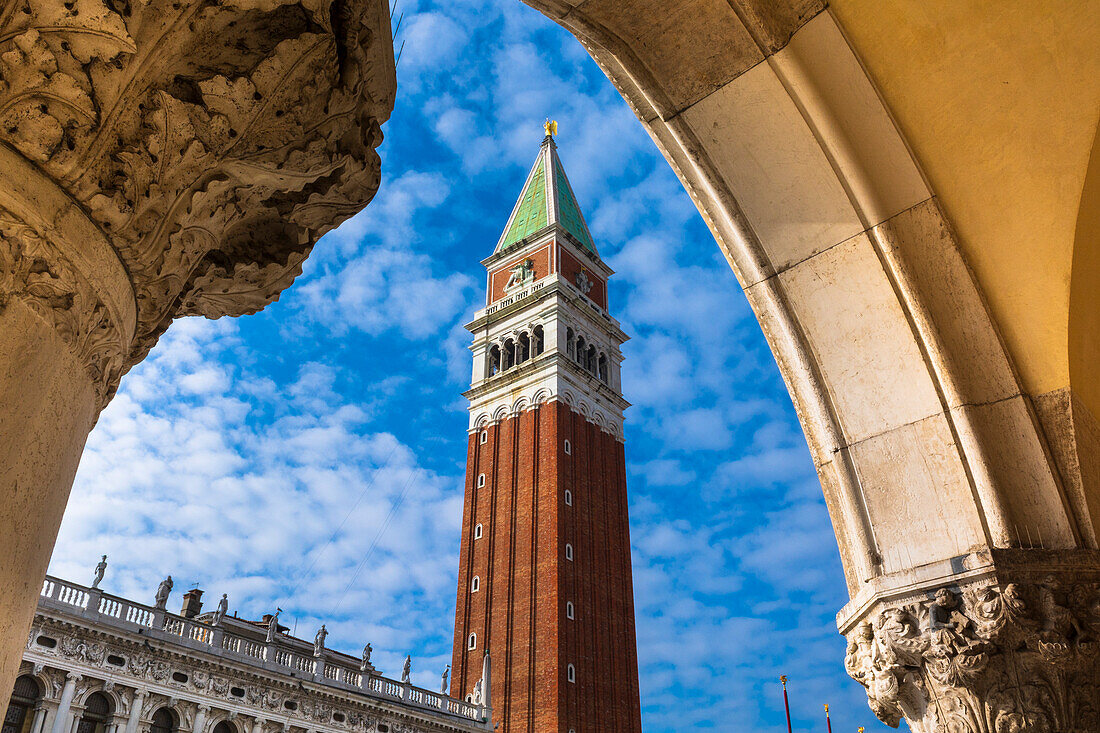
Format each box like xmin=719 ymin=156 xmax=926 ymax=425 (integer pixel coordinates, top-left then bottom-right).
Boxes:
xmin=496 ymin=129 xmax=598 ymax=256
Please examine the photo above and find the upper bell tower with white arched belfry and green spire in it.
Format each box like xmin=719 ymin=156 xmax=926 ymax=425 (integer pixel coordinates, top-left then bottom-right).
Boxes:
xmin=465 ymin=130 xmax=629 ymax=440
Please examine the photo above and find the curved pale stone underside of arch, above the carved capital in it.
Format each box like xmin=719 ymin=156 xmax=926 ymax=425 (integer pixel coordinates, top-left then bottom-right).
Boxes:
xmin=525 ymin=0 xmax=1100 ymax=616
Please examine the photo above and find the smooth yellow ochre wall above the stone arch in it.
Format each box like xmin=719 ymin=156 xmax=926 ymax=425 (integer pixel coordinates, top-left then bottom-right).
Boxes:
xmin=831 ymin=0 xmax=1100 ymax=416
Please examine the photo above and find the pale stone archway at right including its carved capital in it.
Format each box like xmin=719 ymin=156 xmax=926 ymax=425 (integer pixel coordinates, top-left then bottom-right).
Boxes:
xmin=524 ymin=0 xmax=1100 ymax=731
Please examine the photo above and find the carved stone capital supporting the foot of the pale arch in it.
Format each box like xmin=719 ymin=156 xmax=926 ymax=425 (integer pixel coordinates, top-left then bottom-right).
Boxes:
xmin=845 ymin=551 xmax=1100 ymax=733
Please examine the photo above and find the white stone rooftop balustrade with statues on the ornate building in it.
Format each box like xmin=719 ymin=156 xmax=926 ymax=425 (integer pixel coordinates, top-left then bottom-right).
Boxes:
xmin=39 ymin=576 xmax=491 ymax=726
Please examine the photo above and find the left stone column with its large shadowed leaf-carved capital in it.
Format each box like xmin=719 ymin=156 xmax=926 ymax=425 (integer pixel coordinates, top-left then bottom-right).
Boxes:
xmin=0 ymin=0 xmax=396 ymax=695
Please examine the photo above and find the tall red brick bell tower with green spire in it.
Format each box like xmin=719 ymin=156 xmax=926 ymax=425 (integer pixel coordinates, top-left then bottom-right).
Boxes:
xmin=451 ymin=127 xmax=641 ymax=733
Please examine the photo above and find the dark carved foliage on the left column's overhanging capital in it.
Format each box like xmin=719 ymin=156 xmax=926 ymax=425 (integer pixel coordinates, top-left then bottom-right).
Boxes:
xmin=0 ymin=0 xmax=396 ymax=401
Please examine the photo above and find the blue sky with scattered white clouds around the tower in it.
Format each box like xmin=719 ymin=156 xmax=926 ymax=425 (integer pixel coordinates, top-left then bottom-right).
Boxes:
xmin=51 ymin=0 xmax=887 ymax=733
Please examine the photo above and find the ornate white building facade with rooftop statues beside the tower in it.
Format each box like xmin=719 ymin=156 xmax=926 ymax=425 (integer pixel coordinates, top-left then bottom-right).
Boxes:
xmin=3 ymin=577 xmax=492 ymax=733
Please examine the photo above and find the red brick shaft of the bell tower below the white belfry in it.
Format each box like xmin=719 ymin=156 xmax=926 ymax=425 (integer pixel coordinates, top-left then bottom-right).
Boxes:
xmin=451 ymin=402 xmax=641 ymax=733
